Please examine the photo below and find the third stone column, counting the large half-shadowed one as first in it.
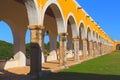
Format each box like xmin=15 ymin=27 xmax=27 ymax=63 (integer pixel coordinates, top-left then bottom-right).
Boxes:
xmin=73 ymin=37 xmax=79 ymax=61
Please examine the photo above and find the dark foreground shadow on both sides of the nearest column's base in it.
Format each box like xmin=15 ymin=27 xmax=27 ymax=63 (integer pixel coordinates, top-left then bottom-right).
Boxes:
xmin=0 ymin=71 xmax=120 ymax=80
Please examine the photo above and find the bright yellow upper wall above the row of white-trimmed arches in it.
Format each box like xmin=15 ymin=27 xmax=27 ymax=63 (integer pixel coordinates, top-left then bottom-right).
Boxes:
xmin=37 ymin=0 xmax=114 ymax=43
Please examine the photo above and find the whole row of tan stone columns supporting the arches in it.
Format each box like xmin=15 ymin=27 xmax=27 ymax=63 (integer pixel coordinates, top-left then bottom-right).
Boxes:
xmin=29 ymin=25 xmax=113 ymax=76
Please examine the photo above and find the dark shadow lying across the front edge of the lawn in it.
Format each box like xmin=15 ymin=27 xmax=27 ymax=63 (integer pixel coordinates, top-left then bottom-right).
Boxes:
xmin=41 ymin=72 xmax=120 ymax=80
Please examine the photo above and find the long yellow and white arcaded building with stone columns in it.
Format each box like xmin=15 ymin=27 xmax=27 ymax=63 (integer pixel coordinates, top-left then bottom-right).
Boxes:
xmin=0 ymin=0 xmax=114 ymax=79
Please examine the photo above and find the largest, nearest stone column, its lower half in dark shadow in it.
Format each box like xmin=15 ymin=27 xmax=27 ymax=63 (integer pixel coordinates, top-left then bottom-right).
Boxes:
xmin=29 ymin=25 xmax=42 ymax=80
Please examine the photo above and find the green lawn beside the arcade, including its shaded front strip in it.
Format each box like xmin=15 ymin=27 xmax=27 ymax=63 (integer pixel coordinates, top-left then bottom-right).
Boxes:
xmin=42 ymin=51 xmax=120 ymax=80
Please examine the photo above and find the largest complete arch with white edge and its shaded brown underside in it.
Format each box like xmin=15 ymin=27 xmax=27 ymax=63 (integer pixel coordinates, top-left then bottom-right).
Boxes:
xmin=42 ymin=0 xmax=65 ymax=34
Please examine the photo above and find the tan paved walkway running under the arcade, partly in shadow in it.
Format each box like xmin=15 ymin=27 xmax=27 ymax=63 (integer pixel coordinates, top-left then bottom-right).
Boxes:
xmin=0 ymin=58 xmax=95 ymax=80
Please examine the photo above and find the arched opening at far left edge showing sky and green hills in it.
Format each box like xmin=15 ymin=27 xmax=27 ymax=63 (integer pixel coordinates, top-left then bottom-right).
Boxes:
xmin=0 ymin=21 xmax=14 ymax=60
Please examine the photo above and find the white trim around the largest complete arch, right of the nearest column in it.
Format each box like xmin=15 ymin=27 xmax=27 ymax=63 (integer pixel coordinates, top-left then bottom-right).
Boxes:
xmin=40 ymin=0 xmax=65 ymax=33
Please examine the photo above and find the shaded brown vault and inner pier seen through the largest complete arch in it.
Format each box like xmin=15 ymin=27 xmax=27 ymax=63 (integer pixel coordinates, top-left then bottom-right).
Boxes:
xmin=43 ymin=4 xmax=64 ymax=61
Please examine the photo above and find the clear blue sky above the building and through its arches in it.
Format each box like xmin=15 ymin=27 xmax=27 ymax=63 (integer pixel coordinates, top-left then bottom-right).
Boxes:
xmin=0 ymin=0 xmax=120 ymax=43
